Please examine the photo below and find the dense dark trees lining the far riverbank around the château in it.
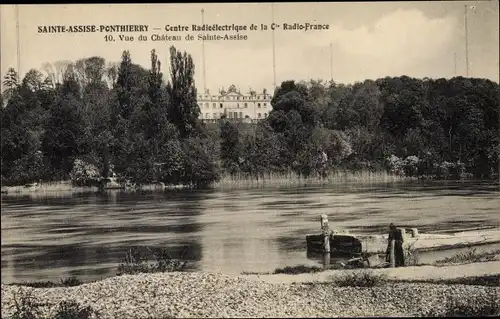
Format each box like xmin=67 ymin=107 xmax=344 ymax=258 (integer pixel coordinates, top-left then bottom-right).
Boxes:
xmin=0 ymin=47 xmax=500 ymax=186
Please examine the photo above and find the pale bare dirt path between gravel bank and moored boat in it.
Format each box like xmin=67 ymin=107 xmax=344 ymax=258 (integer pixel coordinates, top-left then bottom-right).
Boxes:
xmin=243 ymin=261 xmax=500 ymax=283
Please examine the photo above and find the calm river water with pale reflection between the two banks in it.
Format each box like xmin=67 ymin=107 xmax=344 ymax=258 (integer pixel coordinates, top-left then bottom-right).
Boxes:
xmin=1 ymin=182 xmax=500 ymax=283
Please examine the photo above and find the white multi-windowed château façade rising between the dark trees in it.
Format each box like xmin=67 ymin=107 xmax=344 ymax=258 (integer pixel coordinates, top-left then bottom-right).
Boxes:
xmin=198 ymin=85 xmax=273 ymax=122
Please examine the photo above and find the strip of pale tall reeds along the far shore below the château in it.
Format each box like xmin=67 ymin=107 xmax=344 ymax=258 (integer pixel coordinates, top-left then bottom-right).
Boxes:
xmin=213 ymin=171 xmax=407 ymax=188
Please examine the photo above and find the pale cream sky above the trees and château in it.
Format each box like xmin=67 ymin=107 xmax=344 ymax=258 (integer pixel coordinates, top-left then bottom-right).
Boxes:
xmin=0 ymin=1 xmax=499 ymax=93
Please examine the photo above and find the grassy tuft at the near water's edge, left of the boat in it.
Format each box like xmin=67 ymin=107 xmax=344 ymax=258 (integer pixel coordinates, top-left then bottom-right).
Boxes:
xmin=117 ymin=248 xmax=187 ymax=276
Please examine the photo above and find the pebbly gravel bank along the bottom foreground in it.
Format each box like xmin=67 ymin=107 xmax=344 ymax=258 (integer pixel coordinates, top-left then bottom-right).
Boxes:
xmin=1 ymin=267 xmax=500 ymax=318
